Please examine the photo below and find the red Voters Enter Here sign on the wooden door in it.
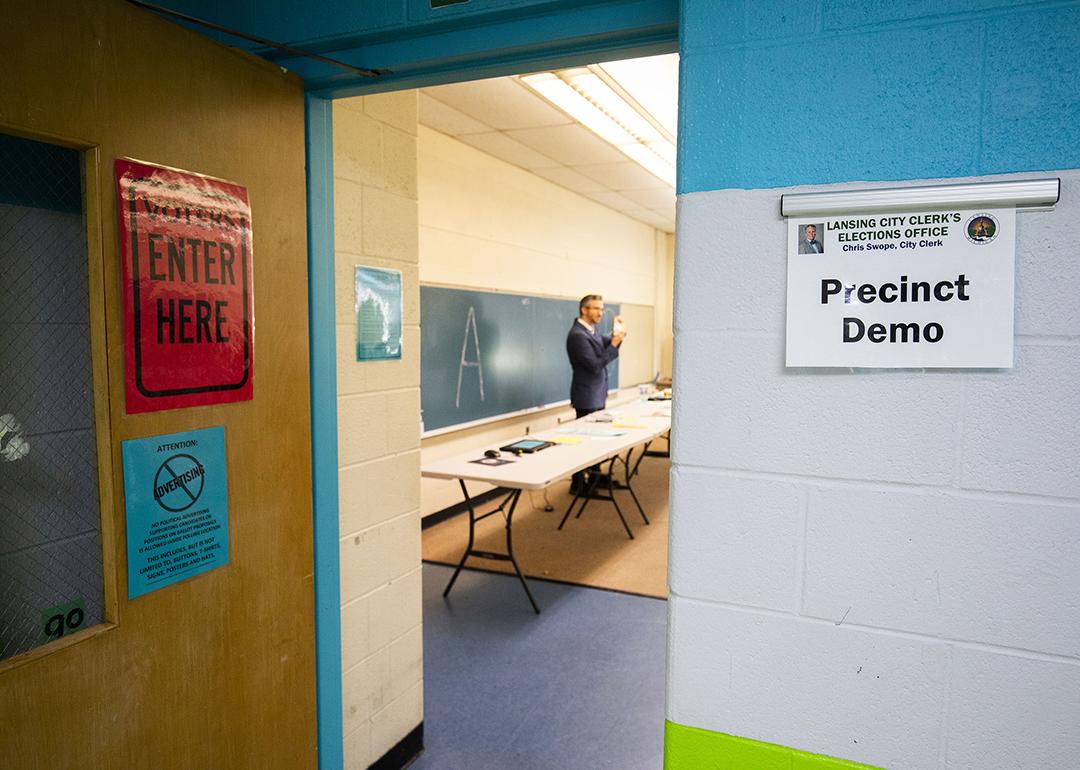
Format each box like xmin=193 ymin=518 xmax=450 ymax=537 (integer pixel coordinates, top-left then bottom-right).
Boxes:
xmin=116 ymin=158 xmax=254 ymax=413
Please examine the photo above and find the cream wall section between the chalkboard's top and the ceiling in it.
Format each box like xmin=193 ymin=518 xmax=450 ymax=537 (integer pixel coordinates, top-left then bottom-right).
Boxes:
xmin=419 ymin=126 xmax=656 ymax=307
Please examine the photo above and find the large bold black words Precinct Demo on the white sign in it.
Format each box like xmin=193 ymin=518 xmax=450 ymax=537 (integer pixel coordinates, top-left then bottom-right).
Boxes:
xmin=821 ymin=273 xmax=971 ymax=343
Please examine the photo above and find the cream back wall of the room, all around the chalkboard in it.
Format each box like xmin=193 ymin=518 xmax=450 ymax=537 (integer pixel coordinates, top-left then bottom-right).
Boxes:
xmin=418 ymin=126 xmax=672 ymax=514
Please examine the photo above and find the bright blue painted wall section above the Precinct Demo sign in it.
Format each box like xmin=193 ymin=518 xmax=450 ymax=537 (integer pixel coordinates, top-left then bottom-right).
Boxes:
xmin=678 ymin=0 xmax=1080 ymax=192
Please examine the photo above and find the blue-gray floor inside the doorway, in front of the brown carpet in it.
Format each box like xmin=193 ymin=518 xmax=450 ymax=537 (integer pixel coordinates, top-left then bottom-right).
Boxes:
xmin=411 ymin=564 xmax=667 ymax=770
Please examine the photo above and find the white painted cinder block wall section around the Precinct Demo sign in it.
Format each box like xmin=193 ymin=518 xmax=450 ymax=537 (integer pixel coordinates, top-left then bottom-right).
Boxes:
xmin=667 ymin=171 xmax=1080 ymax=770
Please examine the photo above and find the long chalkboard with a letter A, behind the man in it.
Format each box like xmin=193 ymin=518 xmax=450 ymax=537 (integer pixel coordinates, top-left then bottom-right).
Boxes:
xmin=420 ymin=286 xmax=619 ymax=431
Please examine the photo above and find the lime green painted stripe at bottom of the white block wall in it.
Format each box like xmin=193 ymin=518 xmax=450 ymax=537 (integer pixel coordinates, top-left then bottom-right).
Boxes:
xmin=664 ymin=721 xmax=881 ymax=770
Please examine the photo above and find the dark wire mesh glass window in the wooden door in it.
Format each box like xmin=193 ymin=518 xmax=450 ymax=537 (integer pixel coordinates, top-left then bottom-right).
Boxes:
xmin=0 ymin=134 xmax=105 ymax=660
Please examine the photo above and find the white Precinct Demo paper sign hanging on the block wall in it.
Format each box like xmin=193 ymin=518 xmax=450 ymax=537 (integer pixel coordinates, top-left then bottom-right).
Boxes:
xmin=787 ymin=207 xmax=1016 ymax=368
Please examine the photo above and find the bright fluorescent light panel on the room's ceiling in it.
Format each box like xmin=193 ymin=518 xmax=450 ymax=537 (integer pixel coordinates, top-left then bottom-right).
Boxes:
xmin=521 ymin=67 xmax=675 ymax=187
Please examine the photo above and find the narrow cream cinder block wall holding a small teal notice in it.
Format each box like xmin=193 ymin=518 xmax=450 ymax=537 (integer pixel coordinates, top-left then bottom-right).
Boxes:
xmin=334 ymin=91 xmax=423 ymax=768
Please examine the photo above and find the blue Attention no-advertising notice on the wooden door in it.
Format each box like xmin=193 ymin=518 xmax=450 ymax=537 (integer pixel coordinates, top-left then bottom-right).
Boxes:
xmin=122 ymin=425 xmax=229 ymax=599
